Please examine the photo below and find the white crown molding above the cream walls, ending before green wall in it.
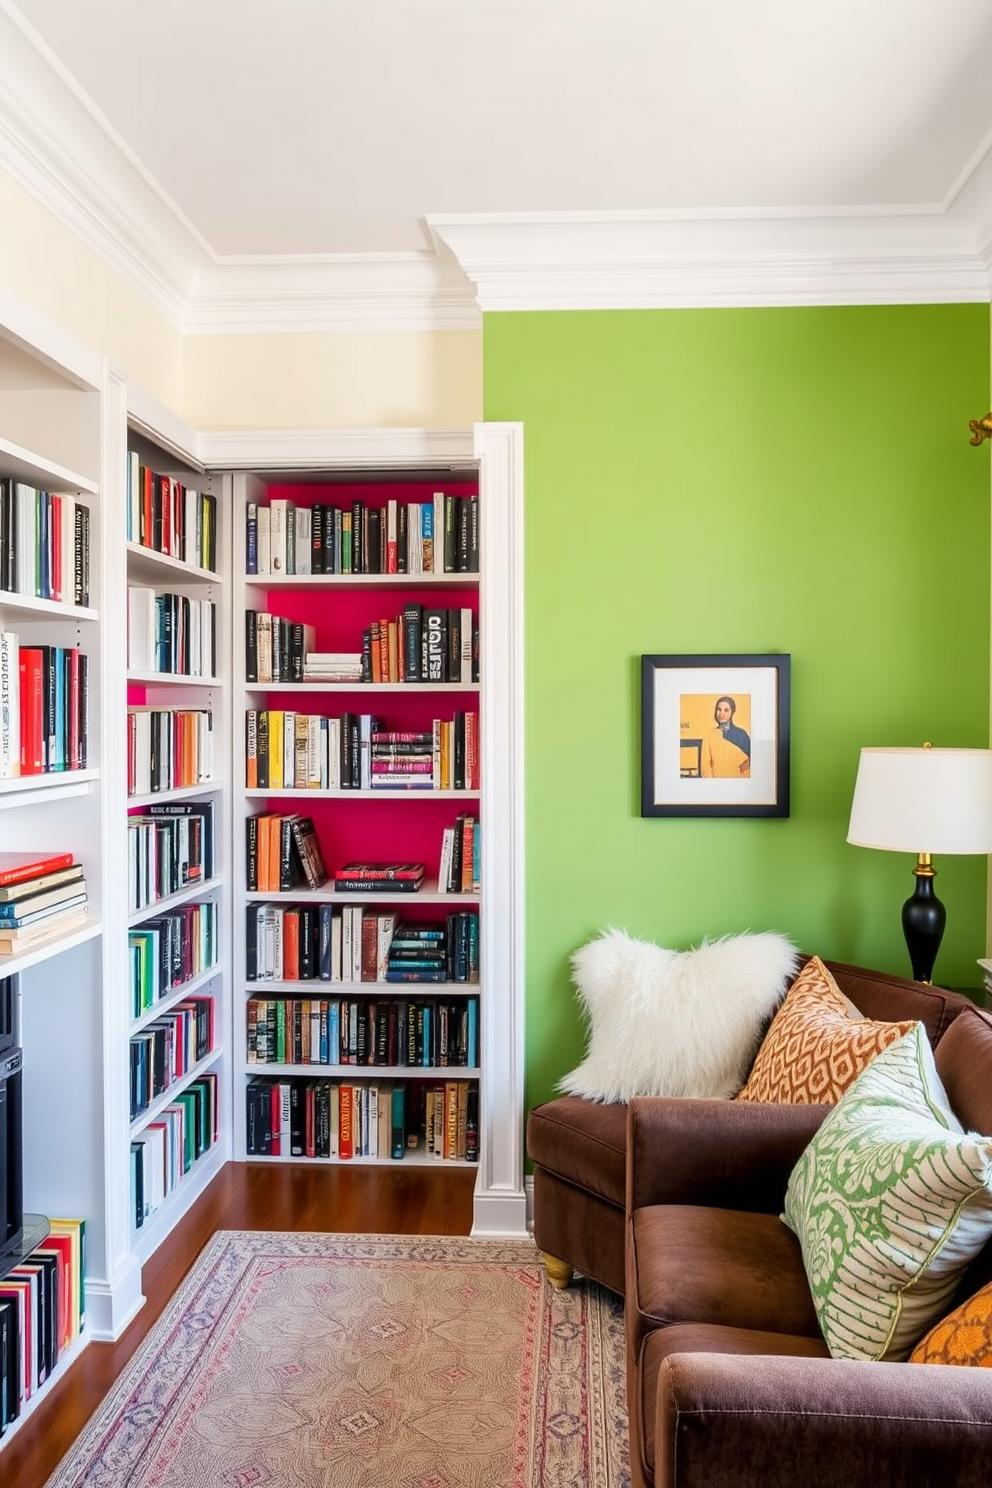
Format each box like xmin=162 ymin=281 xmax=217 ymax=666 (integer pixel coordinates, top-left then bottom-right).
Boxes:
xmin=0 ymin=0 xmax=480 ymax=335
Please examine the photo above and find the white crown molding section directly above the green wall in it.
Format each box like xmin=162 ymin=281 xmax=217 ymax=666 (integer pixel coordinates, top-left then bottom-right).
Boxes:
xmin=427 ymin=208 xmax=991 ymax=311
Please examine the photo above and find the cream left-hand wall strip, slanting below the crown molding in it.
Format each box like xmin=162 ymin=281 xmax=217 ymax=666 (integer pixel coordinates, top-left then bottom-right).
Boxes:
xmin=0 ymin=171 xmax=181 ymax=411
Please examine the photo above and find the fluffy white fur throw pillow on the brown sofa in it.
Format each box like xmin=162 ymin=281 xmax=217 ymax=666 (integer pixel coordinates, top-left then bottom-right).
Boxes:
xmin=559 ymin=930 xmax=800 ymax=1101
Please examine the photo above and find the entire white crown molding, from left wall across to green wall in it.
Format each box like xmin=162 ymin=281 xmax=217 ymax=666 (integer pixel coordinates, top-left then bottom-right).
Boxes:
xmin=0 ymin=0 xmax=992 ymax=325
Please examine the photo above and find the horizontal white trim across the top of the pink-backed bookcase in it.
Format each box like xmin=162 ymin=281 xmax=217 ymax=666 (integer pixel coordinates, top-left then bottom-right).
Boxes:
xmin=196 ymin=429 xmax=476 ymax=470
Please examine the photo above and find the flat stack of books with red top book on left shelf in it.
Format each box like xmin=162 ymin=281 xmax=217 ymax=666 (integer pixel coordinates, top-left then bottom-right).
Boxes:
xmin=0 ymin=853 xmax=86 ymax=955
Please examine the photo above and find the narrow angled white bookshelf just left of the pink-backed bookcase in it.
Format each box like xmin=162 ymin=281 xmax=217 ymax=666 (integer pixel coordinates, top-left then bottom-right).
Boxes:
xmin=120 ymin=422 xmax=232 ymax=1260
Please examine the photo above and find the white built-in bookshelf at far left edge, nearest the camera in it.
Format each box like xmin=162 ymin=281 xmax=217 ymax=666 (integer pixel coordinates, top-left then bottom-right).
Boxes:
xmin=0 ymin=279 xmax=109 ymax=1424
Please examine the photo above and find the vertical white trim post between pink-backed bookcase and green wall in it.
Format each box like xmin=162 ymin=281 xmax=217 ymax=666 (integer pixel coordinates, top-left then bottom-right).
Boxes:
xmin=473 ymin=424 xmax=526 ymax=1235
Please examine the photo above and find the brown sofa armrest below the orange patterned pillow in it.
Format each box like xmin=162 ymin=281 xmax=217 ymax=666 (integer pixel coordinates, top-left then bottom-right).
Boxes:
xmin=626 ymin=1095 xmax=831 ymax=1214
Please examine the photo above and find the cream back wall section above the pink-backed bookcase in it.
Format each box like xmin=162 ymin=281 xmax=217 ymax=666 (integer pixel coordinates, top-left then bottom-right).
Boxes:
xmin=180 ymin=329 xmax=482 ymax=429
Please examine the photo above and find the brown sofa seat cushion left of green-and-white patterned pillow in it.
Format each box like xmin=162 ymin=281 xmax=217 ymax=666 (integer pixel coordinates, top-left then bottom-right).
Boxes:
xmin=626 ymin=1204 xmax=821 ymax=1350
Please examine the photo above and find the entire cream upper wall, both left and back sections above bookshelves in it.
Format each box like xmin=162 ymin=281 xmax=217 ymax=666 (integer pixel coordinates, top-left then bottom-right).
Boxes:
xmin=0 ymin=171 xmax=482 ymax=430
